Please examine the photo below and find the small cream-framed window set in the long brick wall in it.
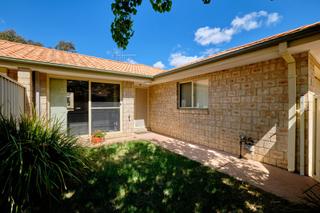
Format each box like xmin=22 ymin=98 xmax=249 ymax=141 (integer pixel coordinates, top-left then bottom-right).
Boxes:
xmin=179 ymin=79 xmax=209 ymax=109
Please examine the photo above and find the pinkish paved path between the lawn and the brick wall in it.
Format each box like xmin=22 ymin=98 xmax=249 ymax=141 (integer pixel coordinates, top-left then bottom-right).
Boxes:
xmin=86 ymin=132 xmax=320 ymax=202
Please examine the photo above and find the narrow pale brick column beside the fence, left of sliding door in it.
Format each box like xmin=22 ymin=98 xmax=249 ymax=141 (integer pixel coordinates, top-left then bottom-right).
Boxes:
xmin=17 ymin=70 xmax=33 ymax=114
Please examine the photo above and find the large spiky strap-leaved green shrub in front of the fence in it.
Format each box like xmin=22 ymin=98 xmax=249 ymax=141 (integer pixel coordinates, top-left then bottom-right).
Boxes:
xmin=0 ymin=115 xmax=86 ymax=212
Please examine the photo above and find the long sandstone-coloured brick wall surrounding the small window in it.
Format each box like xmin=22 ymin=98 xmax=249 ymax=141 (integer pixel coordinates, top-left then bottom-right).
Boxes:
xmin=149 ymin=53 xmax=308 ymax=168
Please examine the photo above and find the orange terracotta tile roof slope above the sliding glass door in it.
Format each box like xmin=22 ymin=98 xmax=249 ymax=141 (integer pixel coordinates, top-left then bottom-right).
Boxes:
xmin=0 ymin=40 xmax=164 ymax=76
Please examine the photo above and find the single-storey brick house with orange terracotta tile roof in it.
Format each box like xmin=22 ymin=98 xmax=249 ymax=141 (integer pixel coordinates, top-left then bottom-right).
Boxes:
xmin=0 ymin=23 xmax=320 ymax=180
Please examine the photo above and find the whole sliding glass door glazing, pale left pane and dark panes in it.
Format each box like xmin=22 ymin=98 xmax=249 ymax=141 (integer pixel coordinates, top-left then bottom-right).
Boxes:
xmin=50 ymin=79 xmax=120 ymax=135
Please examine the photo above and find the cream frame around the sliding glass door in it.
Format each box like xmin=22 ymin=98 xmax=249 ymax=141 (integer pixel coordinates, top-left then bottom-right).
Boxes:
xmin=46 ymin=74 xmax=123 ymax=136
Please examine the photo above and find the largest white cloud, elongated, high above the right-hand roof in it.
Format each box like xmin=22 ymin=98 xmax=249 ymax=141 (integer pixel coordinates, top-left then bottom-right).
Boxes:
xmin=194 ymin=10 xmax=281 ymax=46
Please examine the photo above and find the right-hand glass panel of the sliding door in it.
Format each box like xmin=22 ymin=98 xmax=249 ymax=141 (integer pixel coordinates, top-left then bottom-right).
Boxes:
xmin=91 ymin=82 xmax=120 ymax=133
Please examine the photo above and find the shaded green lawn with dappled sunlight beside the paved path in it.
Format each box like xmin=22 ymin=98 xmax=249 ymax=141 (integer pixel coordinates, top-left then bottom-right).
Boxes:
xmin=57 ymin=141 xmax=306 ymax=212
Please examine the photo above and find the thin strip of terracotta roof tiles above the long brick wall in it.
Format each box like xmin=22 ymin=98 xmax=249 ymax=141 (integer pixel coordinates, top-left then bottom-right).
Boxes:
xmin=159 ymin=22 xmax=320 ymax=75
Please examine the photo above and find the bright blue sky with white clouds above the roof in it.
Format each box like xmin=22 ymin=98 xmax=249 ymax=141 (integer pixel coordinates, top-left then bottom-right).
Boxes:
xmin=0 ymin=0 xmax=320 ymax=69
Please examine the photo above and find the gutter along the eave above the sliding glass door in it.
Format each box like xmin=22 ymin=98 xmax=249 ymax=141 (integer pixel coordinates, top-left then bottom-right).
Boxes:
xmin=0 ymin=56 xmax=153 ymax=80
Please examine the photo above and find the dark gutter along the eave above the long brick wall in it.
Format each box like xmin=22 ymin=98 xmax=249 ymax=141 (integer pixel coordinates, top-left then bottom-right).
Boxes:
xmin=154 ymin=22 xmax=320 ymax=78
